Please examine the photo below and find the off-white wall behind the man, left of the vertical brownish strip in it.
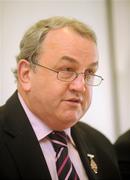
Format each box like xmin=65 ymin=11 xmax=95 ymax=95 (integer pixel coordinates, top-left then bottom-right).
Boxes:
xmin=0 ymin=0 xmax=124 ymax=141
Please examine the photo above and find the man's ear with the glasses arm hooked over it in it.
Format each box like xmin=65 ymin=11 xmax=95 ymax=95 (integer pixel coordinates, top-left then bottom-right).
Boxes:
xmin=17 ymin=59 xmax=32 ymax=91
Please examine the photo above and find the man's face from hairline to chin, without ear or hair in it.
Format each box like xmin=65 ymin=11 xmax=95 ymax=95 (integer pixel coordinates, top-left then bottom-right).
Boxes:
xmin=19 ymin=28 xmax=98 ymax=130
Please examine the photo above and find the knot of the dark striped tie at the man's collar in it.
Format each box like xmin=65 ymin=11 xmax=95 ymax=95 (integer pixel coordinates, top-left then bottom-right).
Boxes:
xmin=49 ymin=131 xmax=67 ymax=152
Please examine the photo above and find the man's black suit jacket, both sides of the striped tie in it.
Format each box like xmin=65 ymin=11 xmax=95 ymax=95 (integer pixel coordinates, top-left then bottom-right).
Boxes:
xmin=0 ymin=92 xmax=120 ymax=180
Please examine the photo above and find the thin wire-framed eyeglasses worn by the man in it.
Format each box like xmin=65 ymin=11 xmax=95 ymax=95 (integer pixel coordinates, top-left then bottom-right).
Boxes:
xmin=32 ymin=62 xmax=104 ymax=86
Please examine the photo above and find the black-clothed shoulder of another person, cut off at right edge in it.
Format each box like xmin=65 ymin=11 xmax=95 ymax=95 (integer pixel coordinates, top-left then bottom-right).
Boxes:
xmin=115 ymin=130 xmax=130 ymax=180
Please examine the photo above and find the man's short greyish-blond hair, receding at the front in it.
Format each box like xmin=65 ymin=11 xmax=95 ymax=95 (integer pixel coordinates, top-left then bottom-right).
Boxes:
xmin=14 ymin=16 xmax=97 ymax=79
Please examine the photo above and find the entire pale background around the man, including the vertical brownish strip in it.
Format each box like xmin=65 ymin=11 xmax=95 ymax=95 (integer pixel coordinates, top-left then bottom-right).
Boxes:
xmin=0 ymin=0 xmax=130 ymax=142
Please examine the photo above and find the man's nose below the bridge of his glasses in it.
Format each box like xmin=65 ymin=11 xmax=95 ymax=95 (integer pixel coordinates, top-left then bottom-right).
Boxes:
xmin=70 ymin=74 xmax=86 ymax=92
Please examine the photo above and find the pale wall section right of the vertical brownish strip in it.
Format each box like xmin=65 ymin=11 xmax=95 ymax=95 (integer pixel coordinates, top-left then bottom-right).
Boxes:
xmin=113 ymin=0 xmax=130 ymax=134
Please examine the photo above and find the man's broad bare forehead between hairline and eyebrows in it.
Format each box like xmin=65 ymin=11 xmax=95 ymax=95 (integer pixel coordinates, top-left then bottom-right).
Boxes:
xmin=41 ymin=27 xmax=98 ymax=67
